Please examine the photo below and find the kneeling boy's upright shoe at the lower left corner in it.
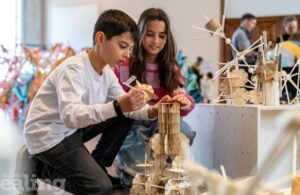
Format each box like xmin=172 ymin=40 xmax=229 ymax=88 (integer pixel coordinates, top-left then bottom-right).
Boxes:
xmin=14 ymin=145 xmax=37 ymax=193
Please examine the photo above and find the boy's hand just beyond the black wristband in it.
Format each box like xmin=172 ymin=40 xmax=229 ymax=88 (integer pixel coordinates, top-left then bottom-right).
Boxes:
xmin=118 ymin=87 xmax=146 ymax=112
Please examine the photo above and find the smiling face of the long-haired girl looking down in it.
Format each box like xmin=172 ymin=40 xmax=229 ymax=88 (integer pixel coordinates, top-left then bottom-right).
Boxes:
xmin=142 ymin=20 xmax=167 ymax=56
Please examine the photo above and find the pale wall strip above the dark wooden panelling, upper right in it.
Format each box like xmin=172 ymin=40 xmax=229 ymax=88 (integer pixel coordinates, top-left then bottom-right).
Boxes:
xmin=226 ymin=0 xmax=300 ymax=18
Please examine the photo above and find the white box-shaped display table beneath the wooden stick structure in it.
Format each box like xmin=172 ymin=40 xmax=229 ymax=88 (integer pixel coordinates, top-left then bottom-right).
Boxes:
xmin=184 ymin=104 xmax=300 ymax=185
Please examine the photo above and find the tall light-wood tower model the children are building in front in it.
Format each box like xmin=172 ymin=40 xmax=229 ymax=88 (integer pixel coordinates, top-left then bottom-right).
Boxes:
xmin=130 ymin=103 xmax=204 ymax=195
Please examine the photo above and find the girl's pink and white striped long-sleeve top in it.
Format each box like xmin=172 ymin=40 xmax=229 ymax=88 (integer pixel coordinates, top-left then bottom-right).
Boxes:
xmin=114 ymin=59 xmax=195 ymax=116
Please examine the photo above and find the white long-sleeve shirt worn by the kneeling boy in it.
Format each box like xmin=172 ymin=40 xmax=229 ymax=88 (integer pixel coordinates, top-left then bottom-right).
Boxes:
xmin=24 ymin=51 xmax=149 ymax=154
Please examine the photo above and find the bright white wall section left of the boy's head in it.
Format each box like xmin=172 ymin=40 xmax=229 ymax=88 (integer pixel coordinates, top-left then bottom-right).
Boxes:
xmin=44 ymin=0 xmax=101 ymax=50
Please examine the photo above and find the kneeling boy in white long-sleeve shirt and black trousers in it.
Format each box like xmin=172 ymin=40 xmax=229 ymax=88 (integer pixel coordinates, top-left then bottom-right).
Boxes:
xmin=16 ymin=10 xmax=163 ymax=194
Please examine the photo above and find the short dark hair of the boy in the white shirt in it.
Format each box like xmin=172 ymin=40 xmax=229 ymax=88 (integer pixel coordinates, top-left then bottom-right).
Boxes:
xmin=93 ymin=9 xmax=138 ymax=45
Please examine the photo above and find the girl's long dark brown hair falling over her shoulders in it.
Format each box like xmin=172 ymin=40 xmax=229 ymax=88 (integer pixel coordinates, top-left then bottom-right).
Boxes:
xmin=129 ymin=8 xmax=183 ymax=94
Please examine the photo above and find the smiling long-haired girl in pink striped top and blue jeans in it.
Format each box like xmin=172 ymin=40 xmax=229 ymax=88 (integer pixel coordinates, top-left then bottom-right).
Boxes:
xmin=115 ymin=8 xmax=195 ymax=186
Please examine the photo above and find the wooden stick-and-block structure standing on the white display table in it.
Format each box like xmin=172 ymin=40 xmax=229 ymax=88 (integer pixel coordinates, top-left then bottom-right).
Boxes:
xmin=193 ymin=0 xmax=300 ymax=105
